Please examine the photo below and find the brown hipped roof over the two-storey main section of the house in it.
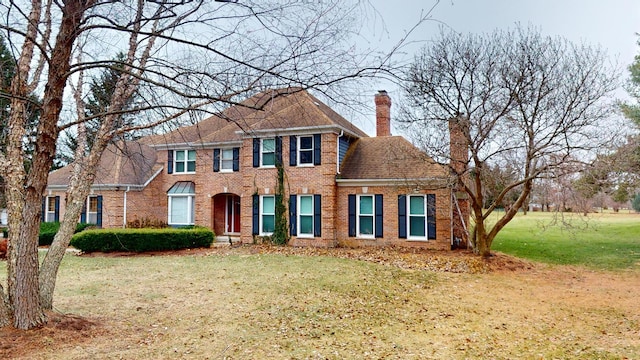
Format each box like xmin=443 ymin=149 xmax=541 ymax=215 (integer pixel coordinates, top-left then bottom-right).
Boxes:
xmin=142 ymin=88 xmax=367 ymax=146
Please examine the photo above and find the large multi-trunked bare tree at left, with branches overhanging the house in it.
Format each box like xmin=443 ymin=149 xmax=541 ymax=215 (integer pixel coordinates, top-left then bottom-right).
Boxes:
xmin=0 ymin=0 xmax=424 ymax=329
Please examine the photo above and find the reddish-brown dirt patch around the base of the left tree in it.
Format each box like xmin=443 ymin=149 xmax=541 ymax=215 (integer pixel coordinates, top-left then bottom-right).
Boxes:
xmin=0 ymin=312 xmax=105 ymax=359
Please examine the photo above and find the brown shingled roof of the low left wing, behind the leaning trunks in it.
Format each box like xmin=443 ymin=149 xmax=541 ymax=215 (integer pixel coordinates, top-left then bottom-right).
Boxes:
xmin=47 ymin=141 xmax=162 ymax=188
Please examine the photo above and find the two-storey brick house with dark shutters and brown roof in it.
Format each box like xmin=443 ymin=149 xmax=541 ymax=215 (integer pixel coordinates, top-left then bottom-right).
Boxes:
xmin=43 ymin=89 xmax=468 ymax=249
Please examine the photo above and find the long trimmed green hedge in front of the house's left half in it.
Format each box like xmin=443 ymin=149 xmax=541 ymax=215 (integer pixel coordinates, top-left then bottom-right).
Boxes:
xmin=71 ymin=228 xmax=214 ymax=253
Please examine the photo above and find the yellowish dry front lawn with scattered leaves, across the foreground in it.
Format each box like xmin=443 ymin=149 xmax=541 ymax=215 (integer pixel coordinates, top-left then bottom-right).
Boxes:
xmin=0 ymin=248 xmax=640 ymax=359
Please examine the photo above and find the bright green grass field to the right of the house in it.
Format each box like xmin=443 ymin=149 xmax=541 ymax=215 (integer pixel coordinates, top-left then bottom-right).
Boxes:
xmin=493 ymin=212 xmax=640 ymax=270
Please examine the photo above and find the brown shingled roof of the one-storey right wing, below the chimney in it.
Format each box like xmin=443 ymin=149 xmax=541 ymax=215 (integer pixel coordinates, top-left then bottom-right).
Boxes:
xmin=339 ymin=136 xmax=448 ymax=181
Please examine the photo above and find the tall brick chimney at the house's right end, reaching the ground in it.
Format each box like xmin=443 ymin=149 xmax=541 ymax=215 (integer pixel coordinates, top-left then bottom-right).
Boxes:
xmin=449 ymin=116 xmax=471 ymax=249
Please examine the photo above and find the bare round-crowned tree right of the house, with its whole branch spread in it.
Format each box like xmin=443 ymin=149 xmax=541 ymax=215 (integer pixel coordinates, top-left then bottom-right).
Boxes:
xmin=402 ymin=28 xmax=618 ymax=256
